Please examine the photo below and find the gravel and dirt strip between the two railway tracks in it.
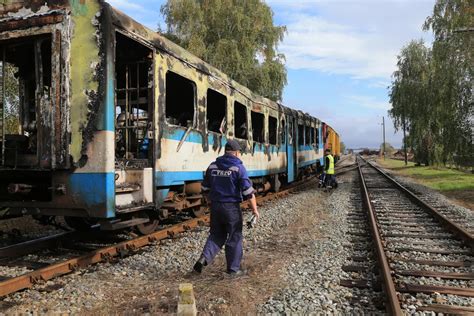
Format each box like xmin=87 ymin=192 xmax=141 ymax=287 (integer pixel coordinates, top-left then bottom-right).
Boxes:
xmin=0 ymin=163 xmax=474 ymax=315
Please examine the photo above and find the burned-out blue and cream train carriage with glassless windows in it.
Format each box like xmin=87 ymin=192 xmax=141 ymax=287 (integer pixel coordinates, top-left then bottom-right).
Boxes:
xmin=0 ymin=0 xmax=323 ymax=232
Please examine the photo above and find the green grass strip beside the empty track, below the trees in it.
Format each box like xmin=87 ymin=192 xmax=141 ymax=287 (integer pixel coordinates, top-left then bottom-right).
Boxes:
xmin=377 ymin=159 xmax=474 ymax=191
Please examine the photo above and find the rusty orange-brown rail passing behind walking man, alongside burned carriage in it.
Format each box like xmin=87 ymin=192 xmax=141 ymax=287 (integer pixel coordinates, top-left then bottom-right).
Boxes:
xmin=0 ymin=177 xmax=316 ymax=297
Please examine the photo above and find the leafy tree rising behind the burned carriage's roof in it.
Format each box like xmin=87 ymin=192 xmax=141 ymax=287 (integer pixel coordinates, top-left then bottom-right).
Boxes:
xmin=161 ymin=0 xmax=287 ymax=101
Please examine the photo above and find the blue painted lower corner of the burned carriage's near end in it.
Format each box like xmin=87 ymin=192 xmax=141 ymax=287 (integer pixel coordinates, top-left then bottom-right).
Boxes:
xmin=69 ymin=172 xmax=115 ymax=217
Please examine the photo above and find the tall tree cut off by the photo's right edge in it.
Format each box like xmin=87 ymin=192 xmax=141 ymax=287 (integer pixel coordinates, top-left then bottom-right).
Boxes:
xmin=423 ymin=0 xmax=474 ymax=168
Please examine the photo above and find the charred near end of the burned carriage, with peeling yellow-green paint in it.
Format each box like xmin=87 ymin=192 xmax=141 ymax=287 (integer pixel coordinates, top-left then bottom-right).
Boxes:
xmin=0 ymin=0 xmax=114 ymax=217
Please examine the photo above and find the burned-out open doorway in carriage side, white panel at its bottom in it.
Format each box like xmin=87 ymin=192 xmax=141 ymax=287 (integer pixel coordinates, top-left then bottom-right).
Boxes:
xmin=115 ymin=32 xmax=154 ymax=213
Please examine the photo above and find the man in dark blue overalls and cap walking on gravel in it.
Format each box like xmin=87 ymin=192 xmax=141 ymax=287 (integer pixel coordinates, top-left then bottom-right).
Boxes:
xmin=194 ymin=140 xmax=260 ymax=276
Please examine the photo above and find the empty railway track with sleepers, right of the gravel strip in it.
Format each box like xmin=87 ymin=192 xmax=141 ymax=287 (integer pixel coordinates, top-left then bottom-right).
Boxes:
xmin=356 ymin=157 xmax=474 ymax=315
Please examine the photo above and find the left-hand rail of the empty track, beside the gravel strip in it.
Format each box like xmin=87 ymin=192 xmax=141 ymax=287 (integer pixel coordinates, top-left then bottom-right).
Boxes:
xmin=357 ymin=161 xmax=403 ymax=316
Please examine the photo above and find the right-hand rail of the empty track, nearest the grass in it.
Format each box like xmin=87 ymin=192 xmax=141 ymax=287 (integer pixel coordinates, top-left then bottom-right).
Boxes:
xmin=362 ymin=158 xmax=474 ymax=250
